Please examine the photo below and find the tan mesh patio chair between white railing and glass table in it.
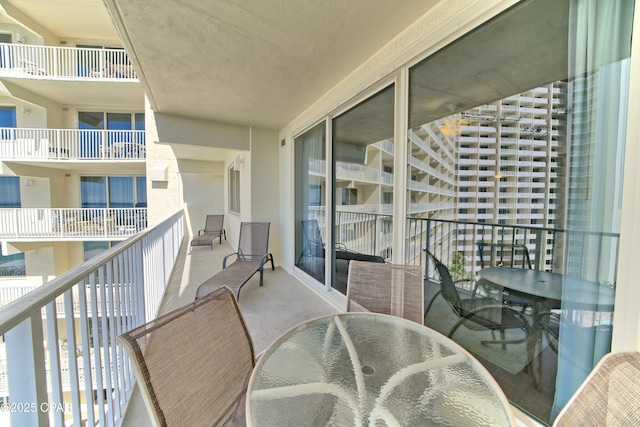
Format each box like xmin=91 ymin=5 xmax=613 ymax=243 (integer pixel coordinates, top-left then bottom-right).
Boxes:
xmin=118 ymin=287 xmax=255 ymax=426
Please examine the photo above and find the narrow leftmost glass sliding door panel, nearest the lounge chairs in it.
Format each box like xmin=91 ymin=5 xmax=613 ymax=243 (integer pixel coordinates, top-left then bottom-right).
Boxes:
xmin=294 ymin=122 xmax=327 ymax=283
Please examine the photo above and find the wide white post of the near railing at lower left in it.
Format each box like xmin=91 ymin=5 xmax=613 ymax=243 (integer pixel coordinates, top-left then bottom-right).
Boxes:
xmin=3 ymin=311 xmax=49 ymax=426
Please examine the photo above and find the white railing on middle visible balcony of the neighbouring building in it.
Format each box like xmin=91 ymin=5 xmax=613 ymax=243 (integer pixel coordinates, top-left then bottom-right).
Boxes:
xmin=0 ymin=128 xmax=147 ymax=161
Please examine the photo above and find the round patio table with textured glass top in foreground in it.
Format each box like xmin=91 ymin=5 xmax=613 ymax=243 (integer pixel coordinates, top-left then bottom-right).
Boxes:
xmin=246 ymin=313 xmax=515 ymax=427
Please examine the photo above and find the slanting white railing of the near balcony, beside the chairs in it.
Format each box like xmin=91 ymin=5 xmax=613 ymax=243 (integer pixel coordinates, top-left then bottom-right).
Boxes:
xmin=0 ymin=211 xmax=184 ymax=426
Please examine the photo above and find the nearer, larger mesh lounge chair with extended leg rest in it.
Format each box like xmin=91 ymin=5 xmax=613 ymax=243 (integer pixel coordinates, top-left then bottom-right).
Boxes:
xmin=196 ymin=222 xmax=275 ymax=299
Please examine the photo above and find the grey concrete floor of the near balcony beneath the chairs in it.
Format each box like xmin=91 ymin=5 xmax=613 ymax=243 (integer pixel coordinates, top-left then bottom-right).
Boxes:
xmin=122 ymin=239 xmax=340 ymax=427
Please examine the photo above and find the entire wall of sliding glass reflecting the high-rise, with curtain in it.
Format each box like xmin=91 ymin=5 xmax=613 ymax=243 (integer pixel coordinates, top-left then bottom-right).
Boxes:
xmin=294 ymin=0 xmax=634 ymax=424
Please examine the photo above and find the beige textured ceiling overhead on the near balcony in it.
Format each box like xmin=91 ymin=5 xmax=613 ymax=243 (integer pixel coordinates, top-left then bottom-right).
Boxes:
xmin=105 ymin=0 xmax=438 ymax=129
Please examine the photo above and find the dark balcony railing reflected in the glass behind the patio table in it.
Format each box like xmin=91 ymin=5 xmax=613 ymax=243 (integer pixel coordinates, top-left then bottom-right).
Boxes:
xmin=406 ymin=217 xmax=620 ymax=286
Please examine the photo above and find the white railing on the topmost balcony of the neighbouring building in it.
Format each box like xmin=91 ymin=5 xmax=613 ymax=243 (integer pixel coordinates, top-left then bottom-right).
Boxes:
xmin=0 ymin=43 xmax=138 ymax=81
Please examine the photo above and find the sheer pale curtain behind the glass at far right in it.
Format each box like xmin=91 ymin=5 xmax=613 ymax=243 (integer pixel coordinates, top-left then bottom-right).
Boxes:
xmin=552 ymin=0 xmax=634 ymax=419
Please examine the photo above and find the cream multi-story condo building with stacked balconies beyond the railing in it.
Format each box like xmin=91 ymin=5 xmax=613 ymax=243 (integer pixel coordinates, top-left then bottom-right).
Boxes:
xmin=0 ymin=2 xmax=147 ymax=418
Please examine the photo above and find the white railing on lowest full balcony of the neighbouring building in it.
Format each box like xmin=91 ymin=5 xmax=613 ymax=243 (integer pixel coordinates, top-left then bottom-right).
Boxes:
xmin=0 ymin=208 xmax=147 ymax=240
